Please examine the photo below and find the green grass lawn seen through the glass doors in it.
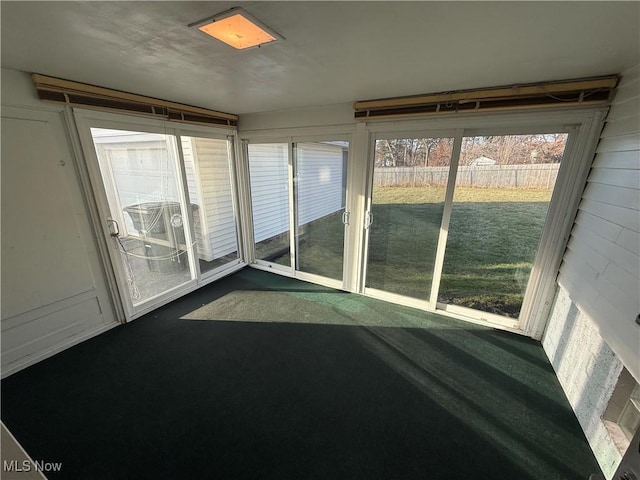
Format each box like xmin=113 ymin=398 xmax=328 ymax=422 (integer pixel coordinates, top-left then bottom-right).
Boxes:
xmin=264 ymin=187 xmax=551 ymax=318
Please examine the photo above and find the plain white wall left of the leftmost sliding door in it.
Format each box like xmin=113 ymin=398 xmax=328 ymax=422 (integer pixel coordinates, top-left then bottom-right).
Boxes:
xmin=1 ymin=69 xmax=117 ymax=376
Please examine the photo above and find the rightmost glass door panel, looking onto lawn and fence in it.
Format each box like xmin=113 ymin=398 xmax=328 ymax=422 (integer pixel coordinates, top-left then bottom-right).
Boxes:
xmin=438 ymin=133 xmax=567 ymax=318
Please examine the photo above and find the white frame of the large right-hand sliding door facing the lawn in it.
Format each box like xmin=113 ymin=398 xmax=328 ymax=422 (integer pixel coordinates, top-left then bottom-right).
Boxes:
xmin=358 ymin=107 xmax=608 ymax=339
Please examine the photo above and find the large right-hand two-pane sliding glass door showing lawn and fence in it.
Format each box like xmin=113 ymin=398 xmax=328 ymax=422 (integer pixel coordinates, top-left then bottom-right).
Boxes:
xmin=363 ymin=130 xmax=568 ymax=328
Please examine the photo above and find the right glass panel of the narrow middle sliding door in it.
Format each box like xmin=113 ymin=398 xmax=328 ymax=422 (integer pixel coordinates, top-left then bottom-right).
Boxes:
xmin=294 ymin=142 xmax=349 ymax=281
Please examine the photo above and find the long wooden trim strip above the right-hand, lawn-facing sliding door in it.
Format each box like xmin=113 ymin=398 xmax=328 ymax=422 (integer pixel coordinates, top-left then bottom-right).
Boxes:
xmin=353 ymin=75 xmax=619 ymax=119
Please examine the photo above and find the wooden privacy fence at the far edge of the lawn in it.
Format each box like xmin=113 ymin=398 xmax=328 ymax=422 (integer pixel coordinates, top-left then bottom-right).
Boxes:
xmin=373 ymin=163 xmax=560 ymax=188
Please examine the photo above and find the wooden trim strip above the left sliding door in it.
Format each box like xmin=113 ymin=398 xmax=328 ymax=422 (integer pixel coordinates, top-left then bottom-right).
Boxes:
xmin=32 ymin=73 xmax=238 ymax=126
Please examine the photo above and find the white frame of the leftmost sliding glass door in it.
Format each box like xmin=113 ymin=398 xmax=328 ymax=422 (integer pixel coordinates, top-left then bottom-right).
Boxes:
xmin=72 ymin=108 xmax=246 ymax=323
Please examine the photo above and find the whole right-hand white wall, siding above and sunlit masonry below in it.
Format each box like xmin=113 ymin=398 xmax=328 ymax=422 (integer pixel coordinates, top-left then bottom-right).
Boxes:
xmin=543 ymin=62 xmax=640 ymax=477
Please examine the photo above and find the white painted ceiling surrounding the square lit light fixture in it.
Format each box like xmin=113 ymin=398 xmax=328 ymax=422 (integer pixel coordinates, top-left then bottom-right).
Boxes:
xmin=0 ymin=1 xmax=640 ymax=114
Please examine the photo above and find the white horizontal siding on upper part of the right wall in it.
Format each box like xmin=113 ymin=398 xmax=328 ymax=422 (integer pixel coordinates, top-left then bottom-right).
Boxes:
xmin=558 ymin=67 xmax=640 ymax=380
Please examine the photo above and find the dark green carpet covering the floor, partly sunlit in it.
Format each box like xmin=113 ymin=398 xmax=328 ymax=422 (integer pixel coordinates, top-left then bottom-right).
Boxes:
xmin=2 ymin=269 xmax=599 ymax=480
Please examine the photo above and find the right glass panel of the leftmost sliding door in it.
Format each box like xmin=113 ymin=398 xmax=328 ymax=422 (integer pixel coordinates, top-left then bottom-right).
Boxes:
xmin=180 ymin=136 xmax=239 ymax=273
